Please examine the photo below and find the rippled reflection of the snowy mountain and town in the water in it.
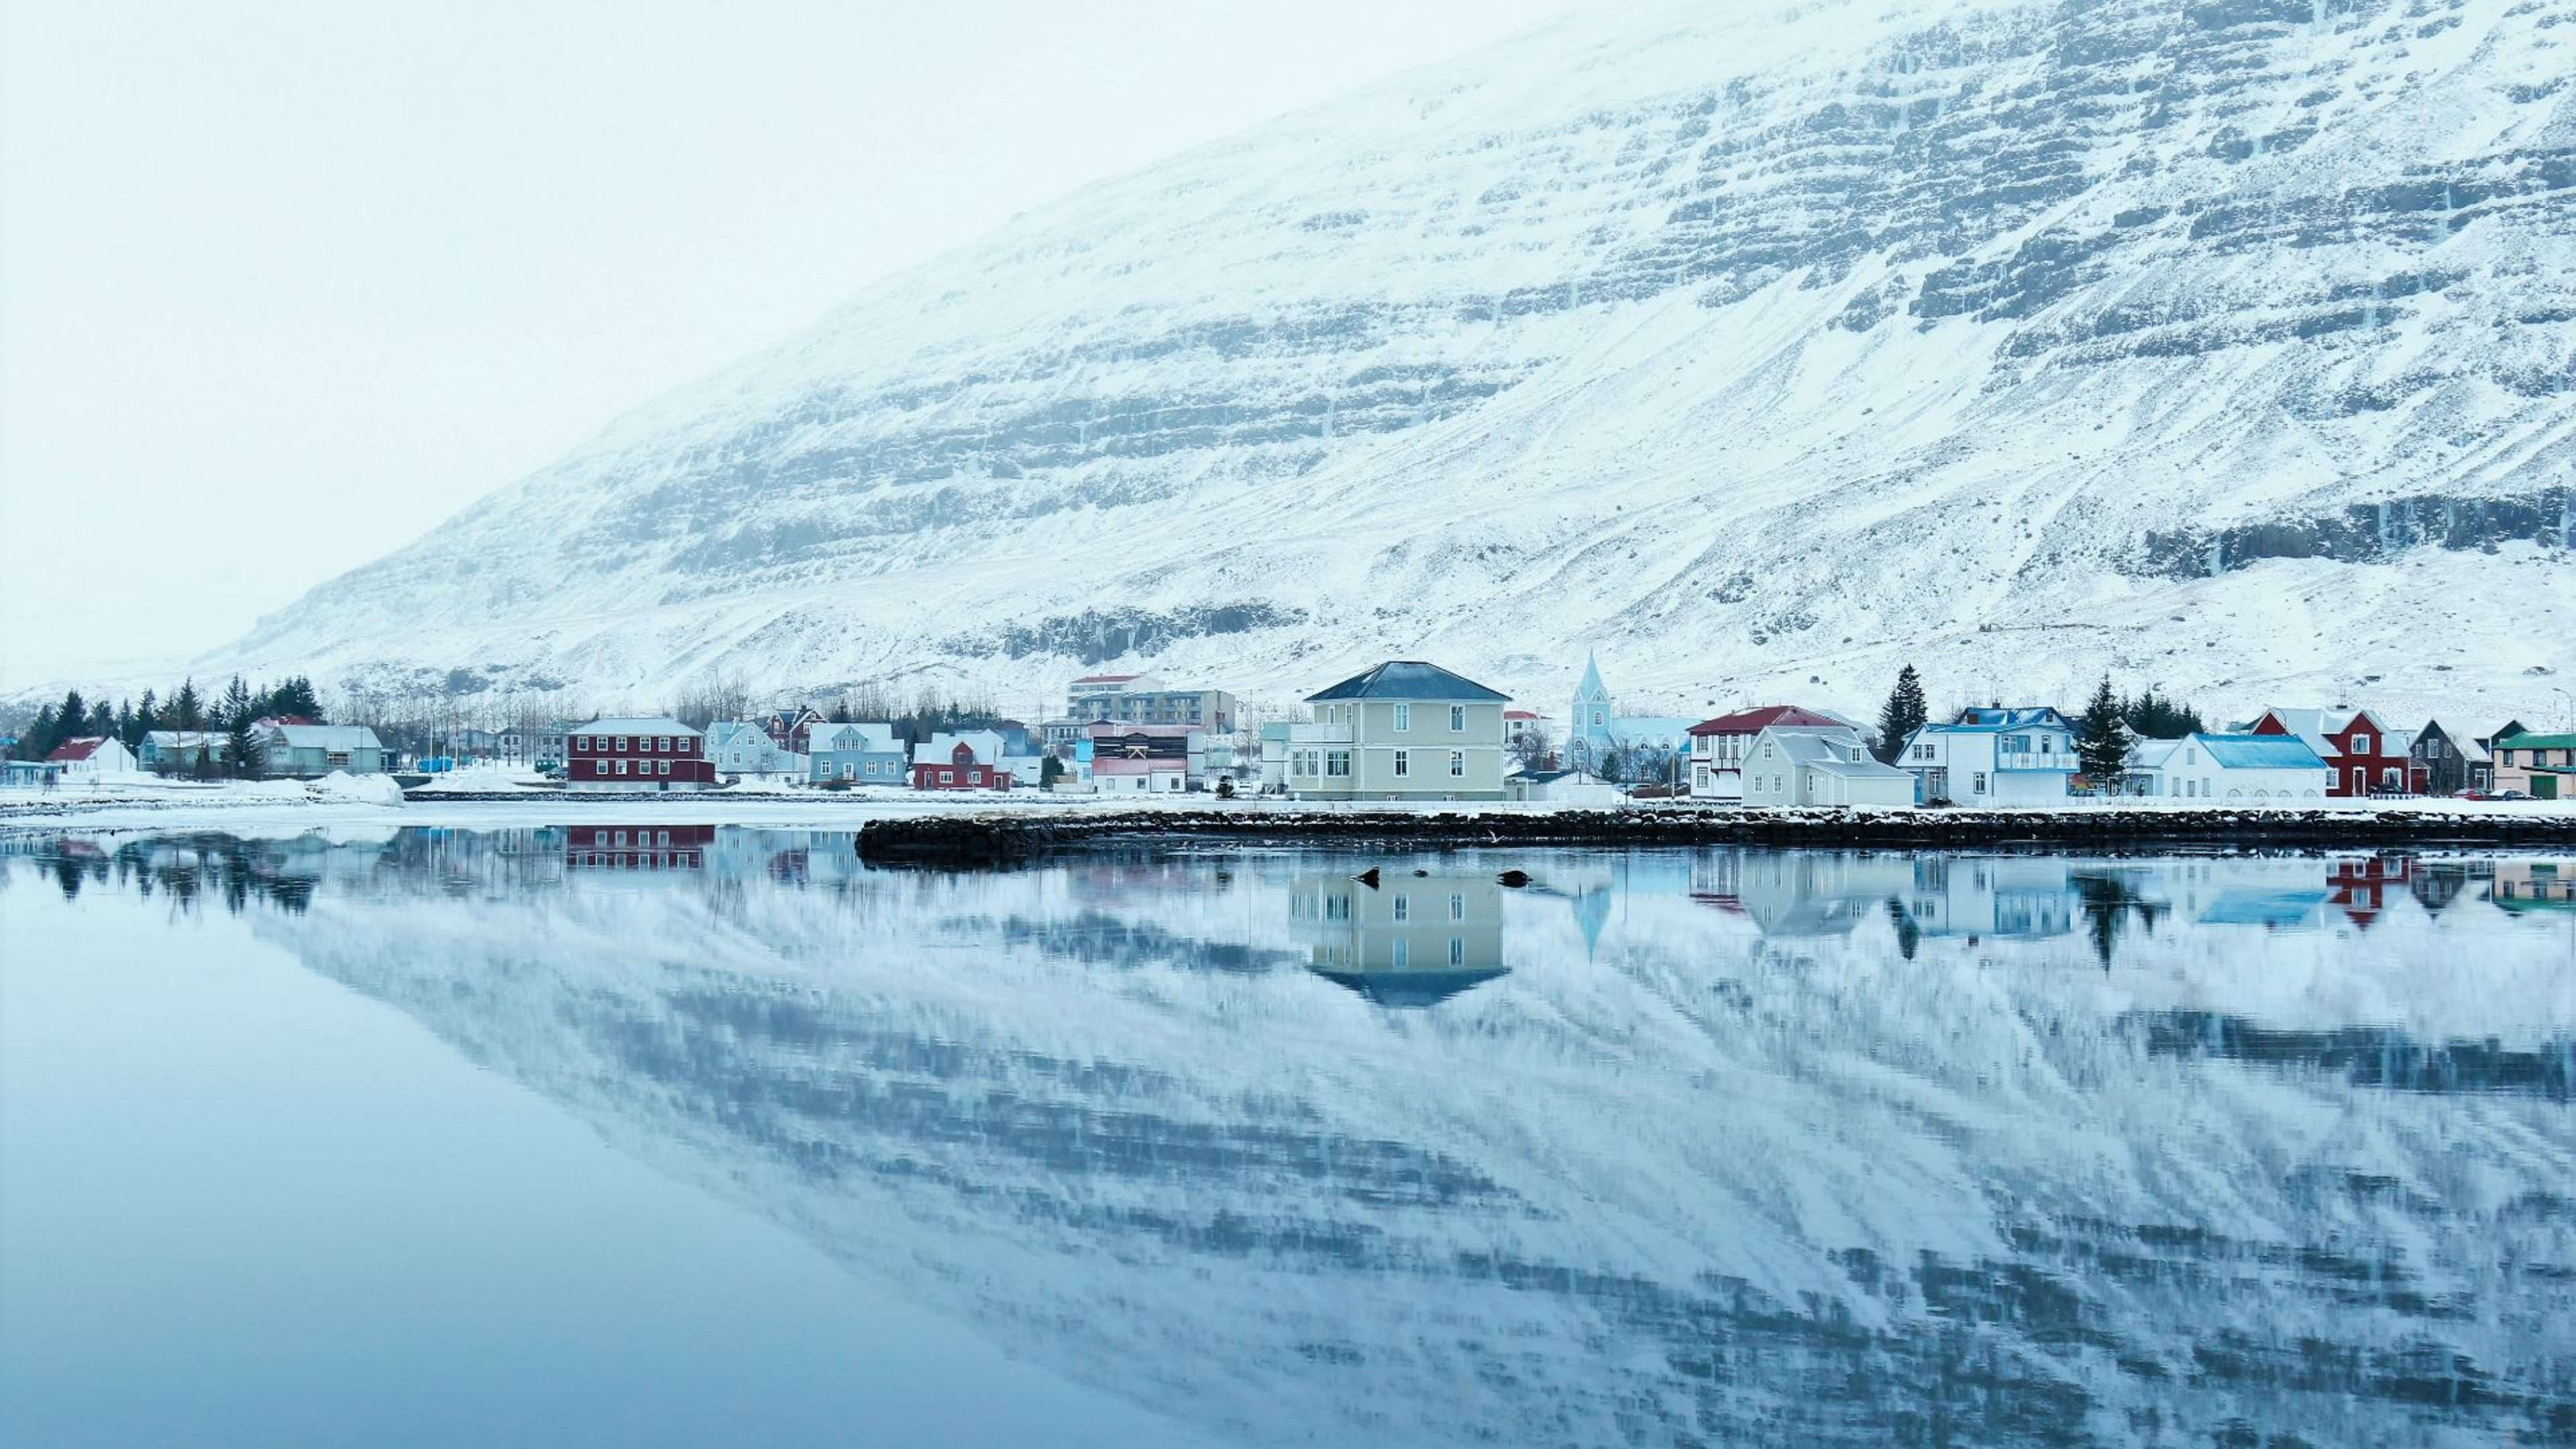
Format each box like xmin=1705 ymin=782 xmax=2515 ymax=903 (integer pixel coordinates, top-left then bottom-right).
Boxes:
xmin=8 ymin=825 xmax=2576 ymax=1446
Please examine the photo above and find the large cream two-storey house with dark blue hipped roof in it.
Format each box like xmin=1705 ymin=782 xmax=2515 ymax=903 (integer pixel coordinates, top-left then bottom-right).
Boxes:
xmin=1288 ymin=660 xmax=1509 ymax=799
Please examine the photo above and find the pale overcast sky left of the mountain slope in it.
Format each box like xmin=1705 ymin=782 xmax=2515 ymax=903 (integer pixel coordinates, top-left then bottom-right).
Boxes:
xmin=0 ymin=0 xmax=1571 ymax=688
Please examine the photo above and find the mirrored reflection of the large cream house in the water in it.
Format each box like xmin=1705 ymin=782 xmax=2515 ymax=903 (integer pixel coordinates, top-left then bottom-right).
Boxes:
xmin=1288 ymin=871 xmax=1507 ymax=1006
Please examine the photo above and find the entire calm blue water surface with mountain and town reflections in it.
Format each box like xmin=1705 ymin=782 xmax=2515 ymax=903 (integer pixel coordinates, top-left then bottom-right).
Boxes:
xmin=0 ymin=825 xmax=2576 ymax=1446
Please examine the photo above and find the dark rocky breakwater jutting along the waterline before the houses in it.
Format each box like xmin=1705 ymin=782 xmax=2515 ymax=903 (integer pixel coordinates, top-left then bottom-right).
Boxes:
xmin=858 ymin=807 xmax=2576 ymax=869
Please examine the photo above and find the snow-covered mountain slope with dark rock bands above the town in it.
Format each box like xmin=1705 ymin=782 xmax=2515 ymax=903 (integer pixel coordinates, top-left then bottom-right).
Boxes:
xmin=209 ymin=0 xmax=2576 ymax=712
